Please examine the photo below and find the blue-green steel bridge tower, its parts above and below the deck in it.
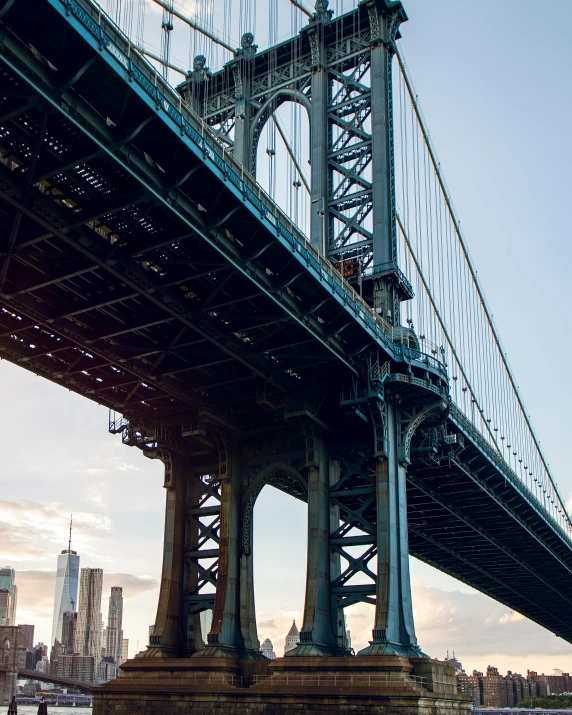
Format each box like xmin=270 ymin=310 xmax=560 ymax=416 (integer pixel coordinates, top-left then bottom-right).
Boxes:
xmin=139 ymin=0 xmax=438 ymax=659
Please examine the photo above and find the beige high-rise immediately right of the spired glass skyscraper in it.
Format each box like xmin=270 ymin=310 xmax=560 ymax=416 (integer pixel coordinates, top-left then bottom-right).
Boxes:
xmin=74 ymin=569 xmax=103 ymax=667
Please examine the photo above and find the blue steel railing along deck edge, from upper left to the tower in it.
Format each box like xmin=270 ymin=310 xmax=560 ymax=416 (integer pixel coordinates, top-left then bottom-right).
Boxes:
xmin=51 ymin=0 xmax=446 ymax=374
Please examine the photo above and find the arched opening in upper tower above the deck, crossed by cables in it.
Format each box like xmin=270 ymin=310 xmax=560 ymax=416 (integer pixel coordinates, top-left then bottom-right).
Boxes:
xmin=253 ymin=99 xmax=311 ymax=236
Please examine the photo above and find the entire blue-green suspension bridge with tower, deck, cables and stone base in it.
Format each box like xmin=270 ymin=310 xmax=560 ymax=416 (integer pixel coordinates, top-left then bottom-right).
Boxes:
xmin=0 ymin=0 xmax=572 ymax=713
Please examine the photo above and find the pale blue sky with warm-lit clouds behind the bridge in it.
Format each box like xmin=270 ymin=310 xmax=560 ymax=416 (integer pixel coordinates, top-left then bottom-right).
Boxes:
xmin=0 ymin=0 xmax=572 ymax=672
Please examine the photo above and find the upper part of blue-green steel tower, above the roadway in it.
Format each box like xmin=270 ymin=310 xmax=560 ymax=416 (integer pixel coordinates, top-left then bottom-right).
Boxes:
xmin=178 ymin=0 xmax=413 ymax=314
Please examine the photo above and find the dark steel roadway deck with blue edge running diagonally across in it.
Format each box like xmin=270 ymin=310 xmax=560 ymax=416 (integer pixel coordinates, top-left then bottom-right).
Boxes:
xmin=0 ymin=0 xmax=572 ymax=642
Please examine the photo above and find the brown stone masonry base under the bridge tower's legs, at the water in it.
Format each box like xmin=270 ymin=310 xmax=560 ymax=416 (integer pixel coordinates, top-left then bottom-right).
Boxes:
xmin=93 ymin=656 xmax=471 ymax=715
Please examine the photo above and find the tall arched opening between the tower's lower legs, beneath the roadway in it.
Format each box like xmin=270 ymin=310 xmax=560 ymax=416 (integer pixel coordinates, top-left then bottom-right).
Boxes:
xmin=252 ymin=478 xmax=308 ymax=657
